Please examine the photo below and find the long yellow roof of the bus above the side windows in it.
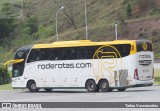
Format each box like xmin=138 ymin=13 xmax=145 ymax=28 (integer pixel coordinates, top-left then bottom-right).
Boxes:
xmin=33 ymin=40 xmax=136 ymax=49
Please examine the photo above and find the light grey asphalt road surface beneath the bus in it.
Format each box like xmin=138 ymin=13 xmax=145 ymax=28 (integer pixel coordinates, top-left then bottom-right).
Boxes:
xmin=0 ymin=85 xmax=160 ymax=111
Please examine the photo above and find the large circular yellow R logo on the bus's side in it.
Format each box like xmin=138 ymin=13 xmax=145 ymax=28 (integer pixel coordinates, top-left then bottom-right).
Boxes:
xmin=92 ymin=45 xmax=122 ymax=82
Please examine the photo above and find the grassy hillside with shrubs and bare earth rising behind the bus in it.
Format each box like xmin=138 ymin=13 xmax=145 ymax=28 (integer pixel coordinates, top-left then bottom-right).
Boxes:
xmin=0 ymin=0 xmax=160 ymax=62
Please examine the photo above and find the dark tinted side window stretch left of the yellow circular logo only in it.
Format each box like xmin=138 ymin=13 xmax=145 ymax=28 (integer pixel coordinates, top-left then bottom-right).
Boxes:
xmin=27 ymin=47 xmax=98 ymax=63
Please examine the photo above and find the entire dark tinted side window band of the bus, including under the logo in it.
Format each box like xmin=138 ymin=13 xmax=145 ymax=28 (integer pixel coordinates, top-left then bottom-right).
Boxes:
xmin=27 ymin=44 xmax=131 ymax=63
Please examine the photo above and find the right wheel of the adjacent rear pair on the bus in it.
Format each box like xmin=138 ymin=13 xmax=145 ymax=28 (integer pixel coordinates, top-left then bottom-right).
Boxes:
xmin=99 ymin=80 xmax=109 ymax=92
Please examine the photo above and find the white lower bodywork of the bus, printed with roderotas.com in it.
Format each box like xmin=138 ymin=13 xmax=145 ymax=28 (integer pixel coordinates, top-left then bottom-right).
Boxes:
xmin=12 ymin=52 xmax=154 ymax=88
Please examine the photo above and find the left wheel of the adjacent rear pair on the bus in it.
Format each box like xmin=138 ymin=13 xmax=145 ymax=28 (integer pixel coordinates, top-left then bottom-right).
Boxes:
xmin=86 ymin=80 xmax=97 ymax=92
